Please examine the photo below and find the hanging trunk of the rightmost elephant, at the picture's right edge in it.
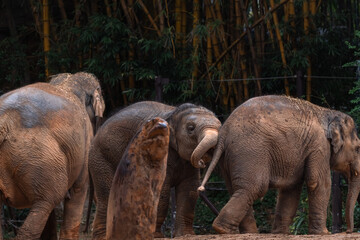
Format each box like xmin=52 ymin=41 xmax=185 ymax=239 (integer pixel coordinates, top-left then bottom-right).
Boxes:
xmin=345 ymin=163 xmax=360 ymax=233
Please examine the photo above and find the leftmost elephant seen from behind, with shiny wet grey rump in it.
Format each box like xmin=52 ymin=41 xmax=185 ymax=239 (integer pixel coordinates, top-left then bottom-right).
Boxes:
xmin=0 ymin=72 xmax=105 ymax=240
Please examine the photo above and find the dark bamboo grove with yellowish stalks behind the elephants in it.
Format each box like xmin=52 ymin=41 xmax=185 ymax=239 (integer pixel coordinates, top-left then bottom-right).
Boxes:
xmin=0 ymin=0 xmax=360 ymax=113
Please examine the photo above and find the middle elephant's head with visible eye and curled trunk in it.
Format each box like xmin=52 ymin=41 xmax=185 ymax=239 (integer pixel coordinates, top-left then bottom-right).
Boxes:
xmin=168 ymin=103 xmax=221 ymax=168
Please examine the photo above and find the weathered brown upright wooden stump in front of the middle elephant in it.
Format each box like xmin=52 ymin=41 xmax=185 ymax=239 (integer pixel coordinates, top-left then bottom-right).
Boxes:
xmin=106 ymin=118 xmax=170 ymax=240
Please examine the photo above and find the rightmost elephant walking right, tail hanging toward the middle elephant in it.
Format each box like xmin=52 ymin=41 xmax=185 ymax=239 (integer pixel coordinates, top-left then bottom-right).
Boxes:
xmin=198 ymin=95 xmax=360 ymax=234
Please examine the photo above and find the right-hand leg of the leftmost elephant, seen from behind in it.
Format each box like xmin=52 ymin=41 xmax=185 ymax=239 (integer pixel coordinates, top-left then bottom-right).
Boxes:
xmin=60 ymin=166 xmax=88 ymax=239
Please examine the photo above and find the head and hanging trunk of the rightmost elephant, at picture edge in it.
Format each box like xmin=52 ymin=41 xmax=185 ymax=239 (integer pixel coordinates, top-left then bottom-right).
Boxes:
xmin=328 ymin=114 xmax=360 ymax=232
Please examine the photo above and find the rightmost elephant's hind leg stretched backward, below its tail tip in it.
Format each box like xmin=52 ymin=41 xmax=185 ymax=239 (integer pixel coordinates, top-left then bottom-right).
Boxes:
xmin=212 ymin=189 xmax=255 ymax=234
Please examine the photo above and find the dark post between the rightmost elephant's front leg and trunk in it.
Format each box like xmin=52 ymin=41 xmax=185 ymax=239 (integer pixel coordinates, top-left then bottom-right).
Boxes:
xmin=331 ymin=172 xmax=342 ymax=233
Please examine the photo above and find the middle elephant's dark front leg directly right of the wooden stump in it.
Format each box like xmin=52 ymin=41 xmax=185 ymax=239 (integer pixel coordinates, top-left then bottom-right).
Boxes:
xmin=154 ymin=180 xmax=171 ymax=238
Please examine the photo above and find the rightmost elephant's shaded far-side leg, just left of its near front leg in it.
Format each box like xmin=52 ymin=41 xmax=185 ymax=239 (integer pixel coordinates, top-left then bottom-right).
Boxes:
xmin=271 ymin=184 xmax=302 ymax=234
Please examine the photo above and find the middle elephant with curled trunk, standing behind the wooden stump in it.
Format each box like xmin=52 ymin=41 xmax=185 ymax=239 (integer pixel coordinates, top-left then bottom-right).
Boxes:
xmin=89 ymin=101 xmax=221 ymax=239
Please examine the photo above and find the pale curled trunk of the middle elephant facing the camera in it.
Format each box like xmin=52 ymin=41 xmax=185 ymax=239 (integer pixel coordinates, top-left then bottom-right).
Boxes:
xmin=190 ymin=129 xmax=219 ymax=168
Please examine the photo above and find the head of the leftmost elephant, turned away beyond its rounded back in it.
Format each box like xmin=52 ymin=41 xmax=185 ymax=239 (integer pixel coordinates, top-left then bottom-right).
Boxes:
xmin=50 ymin=72 xmax=105 ymax=131
